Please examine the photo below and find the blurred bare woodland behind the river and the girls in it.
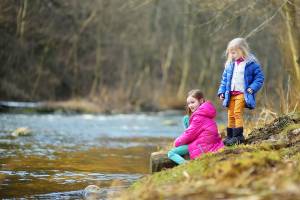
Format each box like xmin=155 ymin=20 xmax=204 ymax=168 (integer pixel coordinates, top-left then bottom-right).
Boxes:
xmin=0 ymin=0 xmax=300 ymax=112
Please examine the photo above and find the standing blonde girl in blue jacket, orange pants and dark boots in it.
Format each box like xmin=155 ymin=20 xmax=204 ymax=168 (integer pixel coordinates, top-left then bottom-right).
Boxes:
xmin=218 ymin=38 xmax=264 ymax=146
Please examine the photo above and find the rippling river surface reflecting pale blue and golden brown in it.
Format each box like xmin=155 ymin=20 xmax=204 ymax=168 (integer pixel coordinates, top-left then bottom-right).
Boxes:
xmin=0 ymin=112 xmax=183 ymax=199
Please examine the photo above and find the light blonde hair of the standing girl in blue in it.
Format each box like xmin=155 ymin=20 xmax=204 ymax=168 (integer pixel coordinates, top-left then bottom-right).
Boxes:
xmin=225 ymin=38 xmax=250 ymax=66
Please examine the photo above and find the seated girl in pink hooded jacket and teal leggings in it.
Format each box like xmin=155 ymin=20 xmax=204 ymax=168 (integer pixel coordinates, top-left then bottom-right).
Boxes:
xmin=168 ymin=90 xmax=224 ymax=164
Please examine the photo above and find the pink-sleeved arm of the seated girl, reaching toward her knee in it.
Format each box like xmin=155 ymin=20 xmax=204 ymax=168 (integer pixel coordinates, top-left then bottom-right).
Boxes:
xmin=174 ymin=116 xmax=202 ymax=147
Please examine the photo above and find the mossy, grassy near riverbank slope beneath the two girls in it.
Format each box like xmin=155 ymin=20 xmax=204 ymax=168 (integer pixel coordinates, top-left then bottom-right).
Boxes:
xmin=116 ymin=113 xmax=300 ymax=200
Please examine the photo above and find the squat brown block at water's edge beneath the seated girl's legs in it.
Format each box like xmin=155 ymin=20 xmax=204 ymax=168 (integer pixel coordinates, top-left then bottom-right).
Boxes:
xmin=150 ymin=151 xmax=177 ymax=173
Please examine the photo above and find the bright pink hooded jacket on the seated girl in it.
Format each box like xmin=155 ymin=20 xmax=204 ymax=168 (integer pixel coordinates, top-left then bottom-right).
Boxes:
xmin=175 ymin=101 xmax=224 ymax=159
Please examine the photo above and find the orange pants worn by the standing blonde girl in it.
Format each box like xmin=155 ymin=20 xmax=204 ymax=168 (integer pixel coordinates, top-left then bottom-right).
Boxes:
xmin=228 ymin=94 xmax=245 ymax=128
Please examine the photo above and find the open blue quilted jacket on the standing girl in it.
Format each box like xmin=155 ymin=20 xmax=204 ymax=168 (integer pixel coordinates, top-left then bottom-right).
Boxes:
xmin=218 ymin=56 xmax=264 ymax=109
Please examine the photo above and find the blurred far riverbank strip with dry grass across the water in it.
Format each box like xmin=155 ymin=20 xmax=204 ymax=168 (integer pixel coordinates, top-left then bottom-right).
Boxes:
xmin=0 ymin=99 xmax=184 ymax=114
